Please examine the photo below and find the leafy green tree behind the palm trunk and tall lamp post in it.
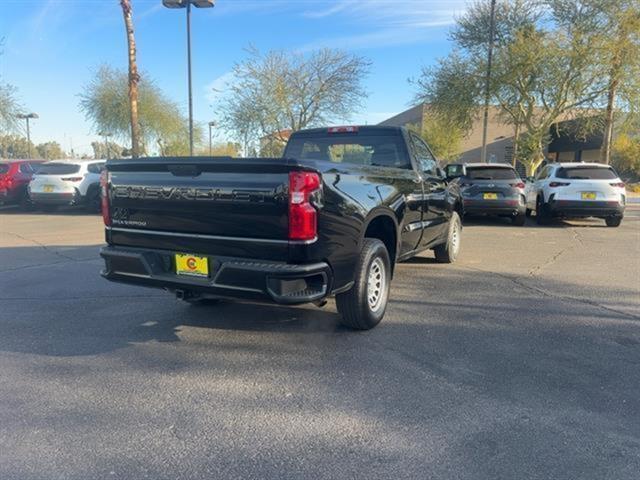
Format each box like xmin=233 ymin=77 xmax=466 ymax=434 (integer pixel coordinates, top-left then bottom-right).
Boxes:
xmin=80 ymin=65 xmax=202 ymax=155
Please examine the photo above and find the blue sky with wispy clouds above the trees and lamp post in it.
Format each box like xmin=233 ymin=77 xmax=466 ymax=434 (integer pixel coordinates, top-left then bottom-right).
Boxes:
xmin=0 ymin=0 xmax=467 ymax=153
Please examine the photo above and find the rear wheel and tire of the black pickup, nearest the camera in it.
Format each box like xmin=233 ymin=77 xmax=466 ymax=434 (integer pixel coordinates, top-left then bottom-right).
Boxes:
xmin=336 ymin=238 xmax=391 ymax=330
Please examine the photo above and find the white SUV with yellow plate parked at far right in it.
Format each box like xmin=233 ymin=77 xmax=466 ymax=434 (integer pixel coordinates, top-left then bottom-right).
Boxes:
xmin=527 ymin=163 xmax=627 ymax=227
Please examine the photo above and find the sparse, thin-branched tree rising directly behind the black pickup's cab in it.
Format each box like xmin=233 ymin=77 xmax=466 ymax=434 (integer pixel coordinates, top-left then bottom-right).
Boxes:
xmin=221 ymin=49 xmax=370 ymax=148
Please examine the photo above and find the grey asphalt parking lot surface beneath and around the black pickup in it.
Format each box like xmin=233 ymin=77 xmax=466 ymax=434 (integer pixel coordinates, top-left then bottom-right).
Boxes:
xmin=0 ymin=205 xmax=640 ymax=480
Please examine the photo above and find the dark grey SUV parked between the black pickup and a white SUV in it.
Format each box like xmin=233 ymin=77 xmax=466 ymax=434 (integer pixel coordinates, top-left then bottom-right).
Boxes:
xmin=446 ymin=163 xmax=526 ymax=226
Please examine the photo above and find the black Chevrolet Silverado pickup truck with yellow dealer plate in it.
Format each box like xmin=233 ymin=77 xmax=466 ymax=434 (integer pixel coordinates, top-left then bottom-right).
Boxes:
xmin=101 ymin=126 xmax=462 ymax=329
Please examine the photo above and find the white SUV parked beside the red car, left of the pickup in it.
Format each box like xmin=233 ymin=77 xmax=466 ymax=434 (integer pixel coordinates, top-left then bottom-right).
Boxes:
xmin=29 ymin=160 xmax=105 ymax=211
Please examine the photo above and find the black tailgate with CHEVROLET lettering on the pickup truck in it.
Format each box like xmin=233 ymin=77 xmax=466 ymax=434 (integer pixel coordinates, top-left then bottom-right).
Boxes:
xmin=107 ymin=158 xmax=300 ymax=259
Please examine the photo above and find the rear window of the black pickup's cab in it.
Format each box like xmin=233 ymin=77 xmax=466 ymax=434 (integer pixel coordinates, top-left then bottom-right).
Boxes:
xmin=285 ymin=134 xmax=411 ymax=168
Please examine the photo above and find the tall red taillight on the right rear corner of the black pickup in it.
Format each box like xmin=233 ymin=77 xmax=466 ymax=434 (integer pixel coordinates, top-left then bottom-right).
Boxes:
xmin=289 ymin=172 xmax=320 ymax=240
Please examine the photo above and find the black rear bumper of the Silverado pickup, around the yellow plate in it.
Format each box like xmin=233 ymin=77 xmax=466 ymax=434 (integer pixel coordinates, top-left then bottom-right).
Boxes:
xmin=100 ymin=246 xmax=332 ymax=304
